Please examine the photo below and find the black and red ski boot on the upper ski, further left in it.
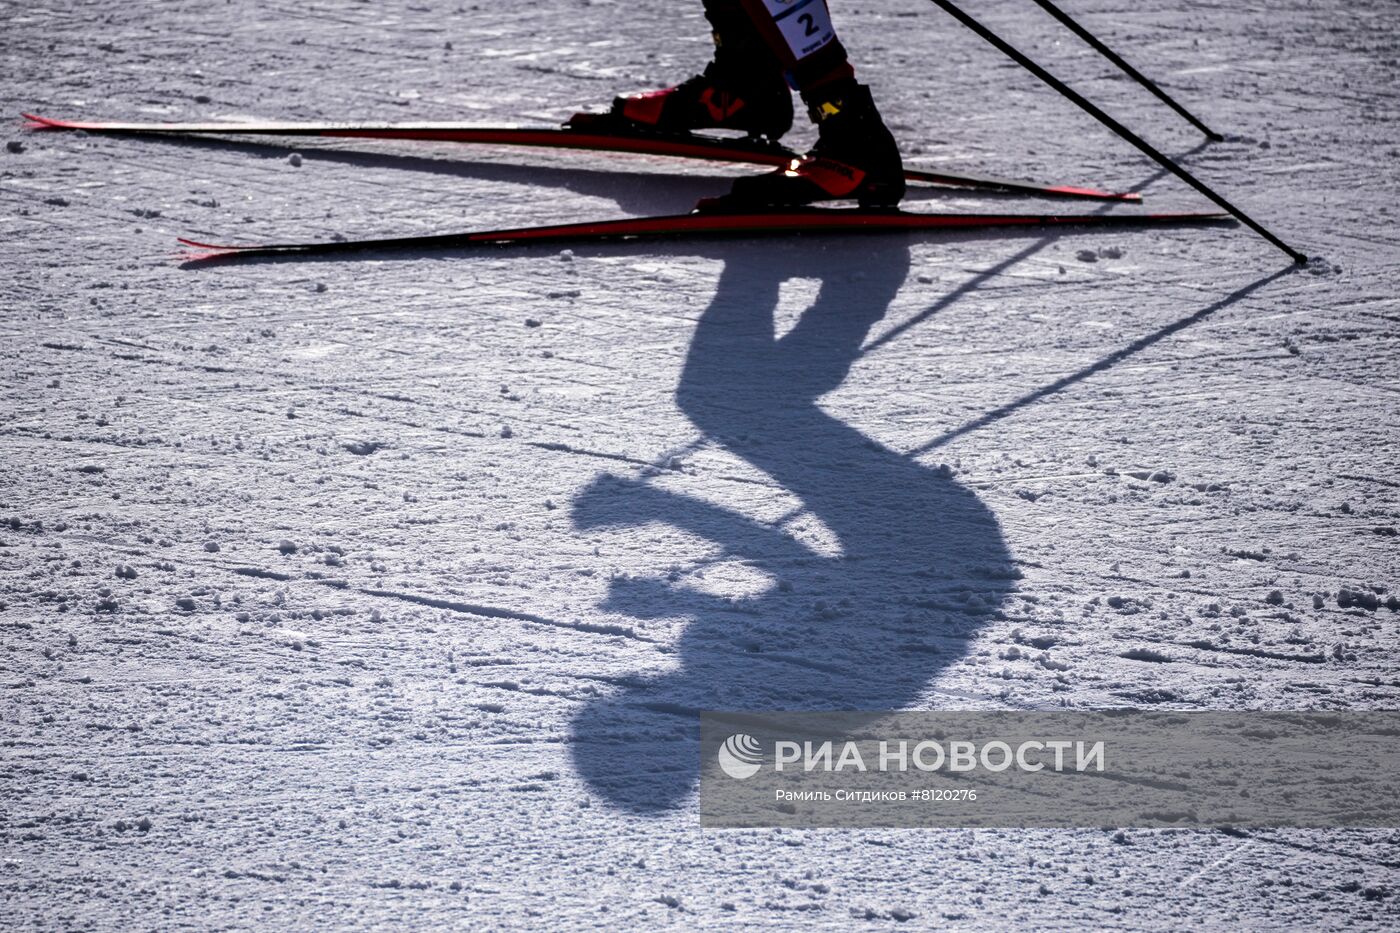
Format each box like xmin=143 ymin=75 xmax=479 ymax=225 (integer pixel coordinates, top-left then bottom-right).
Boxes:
xmin=596 ymin=56 xmax=792 ymax=140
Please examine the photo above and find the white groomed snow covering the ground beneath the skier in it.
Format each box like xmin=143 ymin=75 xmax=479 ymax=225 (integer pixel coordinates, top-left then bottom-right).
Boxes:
xmin=0 ymin=0 xmax=1400 ymax=929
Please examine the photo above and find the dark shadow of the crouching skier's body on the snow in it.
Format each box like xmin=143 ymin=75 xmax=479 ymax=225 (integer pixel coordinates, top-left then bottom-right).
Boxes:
xmin=562 ymin=240 xmax=1015 ymax=811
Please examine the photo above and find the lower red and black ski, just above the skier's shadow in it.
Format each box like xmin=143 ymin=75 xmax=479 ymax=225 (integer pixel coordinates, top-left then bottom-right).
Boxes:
xmin=179 ymin=207 xmax=1229 ymax=262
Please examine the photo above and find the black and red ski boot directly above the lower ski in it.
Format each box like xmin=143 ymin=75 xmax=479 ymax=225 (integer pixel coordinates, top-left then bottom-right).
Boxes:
xmin=711 ymin=80 xmax=904 ymax=210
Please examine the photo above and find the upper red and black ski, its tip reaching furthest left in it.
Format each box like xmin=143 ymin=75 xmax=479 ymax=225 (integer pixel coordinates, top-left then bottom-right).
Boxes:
xmin=21 ymin=113 xmax=1142 ymax=203
